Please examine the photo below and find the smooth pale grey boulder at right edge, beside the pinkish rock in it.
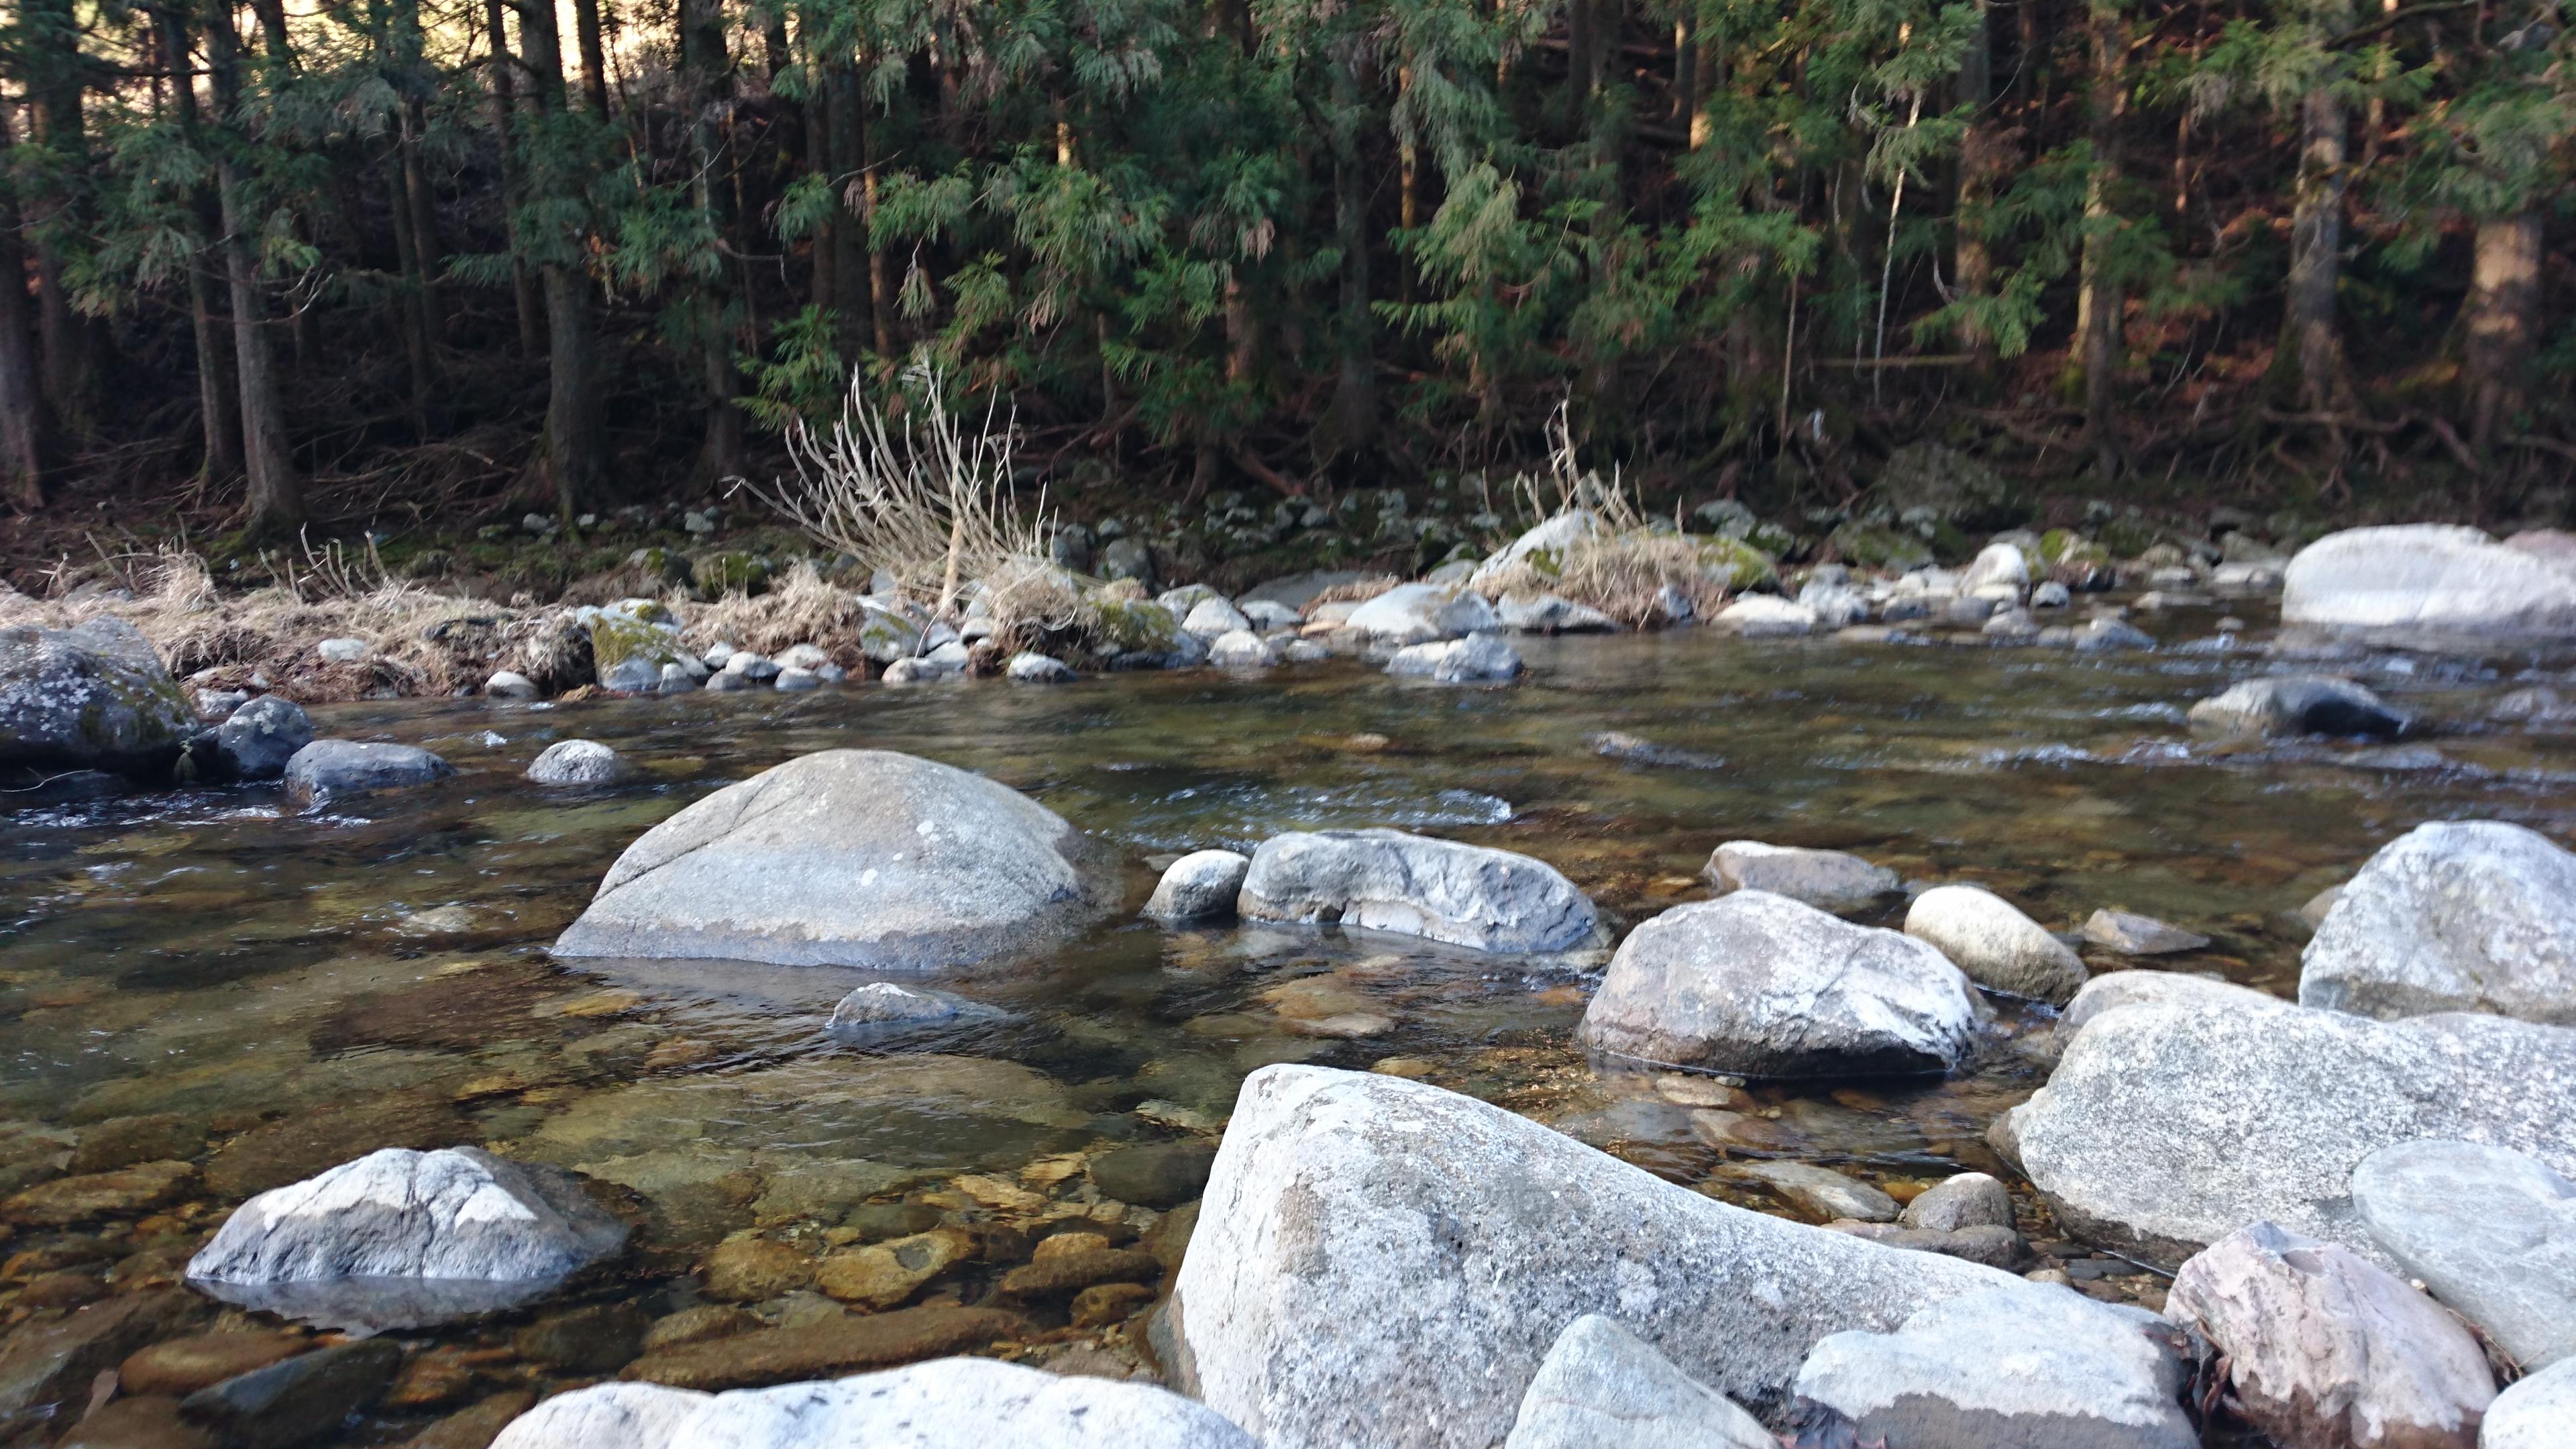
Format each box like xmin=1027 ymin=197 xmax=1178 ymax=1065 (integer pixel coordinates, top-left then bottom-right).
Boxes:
xmin=2352 ymin=1139 xmax=2576 ymax=1369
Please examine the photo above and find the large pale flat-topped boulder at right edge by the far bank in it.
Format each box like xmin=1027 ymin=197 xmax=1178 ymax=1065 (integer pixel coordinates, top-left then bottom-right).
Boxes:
xmin=2279 ymin=523 xmax=2576 ymax=642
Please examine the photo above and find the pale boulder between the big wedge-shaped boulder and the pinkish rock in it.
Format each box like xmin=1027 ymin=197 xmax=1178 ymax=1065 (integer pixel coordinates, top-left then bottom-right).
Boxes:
xmin=1798 ymin=1284 xmax=2200 ymax=1449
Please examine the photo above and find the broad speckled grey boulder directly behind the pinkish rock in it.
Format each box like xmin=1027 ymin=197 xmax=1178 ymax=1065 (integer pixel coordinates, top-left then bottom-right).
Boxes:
xmin=2004 ymin=998 xmax=2576 ymax=1263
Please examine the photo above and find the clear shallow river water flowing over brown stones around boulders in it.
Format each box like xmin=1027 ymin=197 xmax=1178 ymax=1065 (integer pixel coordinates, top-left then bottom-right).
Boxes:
xmin=0 ymin=590 xmax=2576 ymax=1444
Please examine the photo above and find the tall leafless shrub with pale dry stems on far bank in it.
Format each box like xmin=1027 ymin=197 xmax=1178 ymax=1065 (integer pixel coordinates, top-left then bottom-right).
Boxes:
xmin=734 ymin=358 xmax=1046 ymax=614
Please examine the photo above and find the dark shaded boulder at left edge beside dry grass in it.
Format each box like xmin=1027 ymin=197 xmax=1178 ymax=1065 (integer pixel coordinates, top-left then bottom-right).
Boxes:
xmin=0 ymin=616 xmax=196 ymax=773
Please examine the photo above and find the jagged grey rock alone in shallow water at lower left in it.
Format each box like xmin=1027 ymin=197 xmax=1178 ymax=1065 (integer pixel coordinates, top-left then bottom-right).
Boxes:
xmin=188 ymin=1147 xmax=626 ymax=1326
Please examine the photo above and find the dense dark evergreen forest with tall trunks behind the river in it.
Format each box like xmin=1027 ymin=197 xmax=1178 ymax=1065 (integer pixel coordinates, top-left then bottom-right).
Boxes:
xmin=0 ymin=0 xmax=2576 ymax=536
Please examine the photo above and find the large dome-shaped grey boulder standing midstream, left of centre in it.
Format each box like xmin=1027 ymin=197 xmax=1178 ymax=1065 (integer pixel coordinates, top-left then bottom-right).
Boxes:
xmin=554 ymin=750 xmax=1108 ymax=969
